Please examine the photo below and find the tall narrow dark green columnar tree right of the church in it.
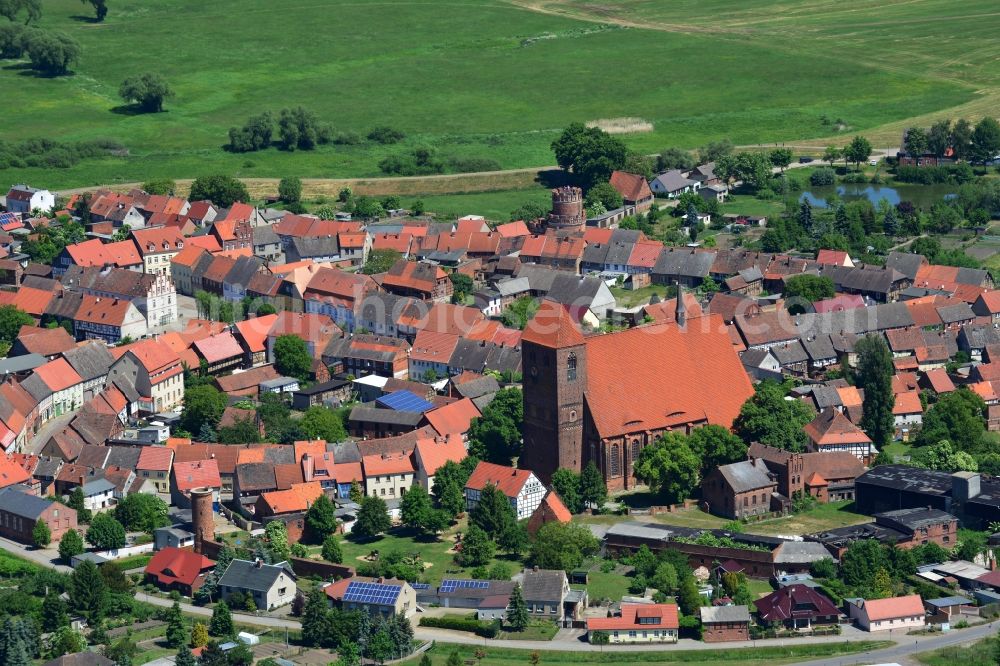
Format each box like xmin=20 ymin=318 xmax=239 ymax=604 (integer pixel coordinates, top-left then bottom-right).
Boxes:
xmin=855 ymin=335 xmax=896 ymax=449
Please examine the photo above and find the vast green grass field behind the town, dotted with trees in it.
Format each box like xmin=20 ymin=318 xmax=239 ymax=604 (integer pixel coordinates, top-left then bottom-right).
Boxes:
xmin=0 ymin=0 xmax=984 ymax=188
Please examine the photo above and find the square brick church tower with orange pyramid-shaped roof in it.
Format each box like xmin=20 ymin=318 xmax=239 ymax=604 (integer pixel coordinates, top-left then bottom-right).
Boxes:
xmin=519 ymin=301 xmax=587 ymax=482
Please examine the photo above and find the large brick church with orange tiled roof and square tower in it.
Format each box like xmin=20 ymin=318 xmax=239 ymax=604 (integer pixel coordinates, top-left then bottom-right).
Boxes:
xmin=520 ymin=298 xmax=753 ymax=492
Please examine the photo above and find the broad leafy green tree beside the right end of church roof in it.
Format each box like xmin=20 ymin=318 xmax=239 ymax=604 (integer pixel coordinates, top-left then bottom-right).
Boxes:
xmin=733 ymin=381 xmax=813 ymax=451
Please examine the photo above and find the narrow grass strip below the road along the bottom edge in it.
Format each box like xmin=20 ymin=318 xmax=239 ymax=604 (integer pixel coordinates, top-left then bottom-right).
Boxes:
xmin=402 ymin=641 xmax=890 ymax=666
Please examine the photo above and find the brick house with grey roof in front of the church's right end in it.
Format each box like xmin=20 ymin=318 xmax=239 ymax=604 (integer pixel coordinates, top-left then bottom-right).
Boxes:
xmin=701 ymin=460 xmax=777 ymax=520
